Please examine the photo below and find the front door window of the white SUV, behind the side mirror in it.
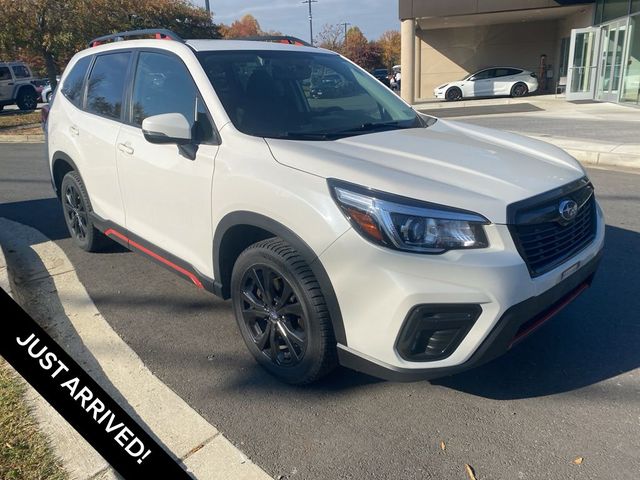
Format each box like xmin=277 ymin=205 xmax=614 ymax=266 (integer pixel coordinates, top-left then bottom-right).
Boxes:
xmin=132 ymin=52 xmax=196 ymax=126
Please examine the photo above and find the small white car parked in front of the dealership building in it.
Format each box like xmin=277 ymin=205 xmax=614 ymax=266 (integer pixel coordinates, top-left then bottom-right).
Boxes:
xmin=433 ymin=67 xmax=538 ymax=102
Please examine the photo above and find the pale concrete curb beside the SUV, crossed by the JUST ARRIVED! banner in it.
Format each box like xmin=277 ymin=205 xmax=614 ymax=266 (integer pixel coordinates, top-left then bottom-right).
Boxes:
xmin=0 ymin=218 xmax=271 ymax=480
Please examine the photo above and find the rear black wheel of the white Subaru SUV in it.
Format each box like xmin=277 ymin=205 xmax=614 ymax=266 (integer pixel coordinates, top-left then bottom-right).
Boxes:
xmin=60 ymin=171 xmax=113 ymax=252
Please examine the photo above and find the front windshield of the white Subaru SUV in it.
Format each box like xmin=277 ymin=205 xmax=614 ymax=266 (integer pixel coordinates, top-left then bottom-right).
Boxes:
xmin=198 ymin=51 xmax=426 ymax=140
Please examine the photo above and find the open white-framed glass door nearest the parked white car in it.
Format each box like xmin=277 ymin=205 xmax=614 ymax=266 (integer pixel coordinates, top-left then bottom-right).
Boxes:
xmin=567 ymin=27 xmax=600 ymax=100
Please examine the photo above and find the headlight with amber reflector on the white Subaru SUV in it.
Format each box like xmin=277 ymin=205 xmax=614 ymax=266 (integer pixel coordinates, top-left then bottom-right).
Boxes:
xmin=329 ymin=180 xmax=489 ymax=254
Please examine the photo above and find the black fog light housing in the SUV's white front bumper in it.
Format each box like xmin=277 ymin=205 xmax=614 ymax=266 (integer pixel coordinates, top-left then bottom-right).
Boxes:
xmin=396 ymin=304 xmax=482 ymax=362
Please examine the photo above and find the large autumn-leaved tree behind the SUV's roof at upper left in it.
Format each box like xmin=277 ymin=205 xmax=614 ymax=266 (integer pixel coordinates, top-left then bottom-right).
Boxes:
xmin=0 ymin=0 xmax=219 ymax=87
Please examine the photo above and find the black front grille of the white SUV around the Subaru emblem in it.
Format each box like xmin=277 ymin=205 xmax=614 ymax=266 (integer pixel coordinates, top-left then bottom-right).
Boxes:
xmin=510 ymin=181 xmax=596 ymax=277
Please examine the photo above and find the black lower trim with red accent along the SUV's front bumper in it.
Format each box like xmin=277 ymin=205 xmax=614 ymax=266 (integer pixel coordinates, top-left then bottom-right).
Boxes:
xmin=338 ymin=251 xmax=602 ymax=382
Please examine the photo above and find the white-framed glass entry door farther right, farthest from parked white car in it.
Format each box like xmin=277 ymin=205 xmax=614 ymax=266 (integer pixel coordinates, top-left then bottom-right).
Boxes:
xmin=597 ymin=20 xmax=627 ymax=102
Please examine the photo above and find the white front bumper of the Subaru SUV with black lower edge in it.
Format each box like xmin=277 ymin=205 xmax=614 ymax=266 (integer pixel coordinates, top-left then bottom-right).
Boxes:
xmin=320 ymin=204 xmax=604 ymax=381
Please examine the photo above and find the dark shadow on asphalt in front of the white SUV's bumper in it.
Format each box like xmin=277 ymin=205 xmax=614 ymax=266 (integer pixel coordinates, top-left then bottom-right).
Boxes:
xmin=432 ymin=226 xmax=640 ymax=400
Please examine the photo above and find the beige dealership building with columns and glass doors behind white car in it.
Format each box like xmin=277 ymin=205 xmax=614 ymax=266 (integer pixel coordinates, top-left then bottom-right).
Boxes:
xmin=399 ymin=0 xmax=640 ymax=105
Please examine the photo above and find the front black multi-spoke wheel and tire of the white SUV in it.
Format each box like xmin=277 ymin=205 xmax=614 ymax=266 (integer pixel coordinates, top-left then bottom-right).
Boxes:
xmin=231 ymin=237 xmax=337 ymax=385
